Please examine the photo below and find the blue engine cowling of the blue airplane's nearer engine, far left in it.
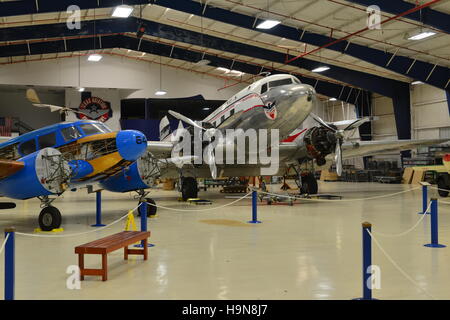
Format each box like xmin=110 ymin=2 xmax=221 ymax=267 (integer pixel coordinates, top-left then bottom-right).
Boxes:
xmin=0 ymin=148 xmax=71 ymax=200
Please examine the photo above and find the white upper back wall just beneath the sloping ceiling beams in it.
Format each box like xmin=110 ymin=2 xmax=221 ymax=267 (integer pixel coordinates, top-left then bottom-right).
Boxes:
xmin=0 ymin=55 xmax=245 ymax=100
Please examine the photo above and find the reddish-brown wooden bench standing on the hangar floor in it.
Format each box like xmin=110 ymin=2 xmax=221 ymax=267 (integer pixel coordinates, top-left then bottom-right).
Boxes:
xmin=75 ymin=231 xmax=150 ymax=281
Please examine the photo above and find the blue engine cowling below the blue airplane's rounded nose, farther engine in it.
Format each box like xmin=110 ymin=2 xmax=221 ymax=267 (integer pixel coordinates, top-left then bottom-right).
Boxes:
xmin=100 ymin=152 xmax=161 ymax=192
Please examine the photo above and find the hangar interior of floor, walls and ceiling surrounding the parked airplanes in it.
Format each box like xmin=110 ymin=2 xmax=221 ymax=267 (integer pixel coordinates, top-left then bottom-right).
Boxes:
xmin=0 ymin=0 xmax=450 ymax=300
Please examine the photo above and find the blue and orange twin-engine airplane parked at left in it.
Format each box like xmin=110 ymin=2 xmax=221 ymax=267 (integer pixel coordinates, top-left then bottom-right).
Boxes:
xmin=0 ymin=120 xmax=148 ymax=231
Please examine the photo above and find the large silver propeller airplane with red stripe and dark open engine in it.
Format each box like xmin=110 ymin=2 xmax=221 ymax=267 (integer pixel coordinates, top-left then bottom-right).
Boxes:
xmin=145 ymin=74 xmax=446 ymax=199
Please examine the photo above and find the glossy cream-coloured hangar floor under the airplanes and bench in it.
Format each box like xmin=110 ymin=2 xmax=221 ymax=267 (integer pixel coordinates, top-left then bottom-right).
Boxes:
xmin=0 ymin=182 xmax=450 ymax=300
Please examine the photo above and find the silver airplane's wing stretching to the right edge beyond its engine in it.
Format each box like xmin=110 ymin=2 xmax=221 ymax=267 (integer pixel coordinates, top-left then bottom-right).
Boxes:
xmin=326 ymin=139 xmax=448 ymax=160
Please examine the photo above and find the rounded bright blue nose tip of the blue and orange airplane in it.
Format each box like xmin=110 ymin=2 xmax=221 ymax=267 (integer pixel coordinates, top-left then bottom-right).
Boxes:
xmin=116 ymin=130 xmax=147 ymax=161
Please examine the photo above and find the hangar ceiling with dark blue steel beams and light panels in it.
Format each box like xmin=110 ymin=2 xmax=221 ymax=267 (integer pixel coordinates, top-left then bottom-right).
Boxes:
xmin=0 ymin=0 xmax=450 ymax=102
